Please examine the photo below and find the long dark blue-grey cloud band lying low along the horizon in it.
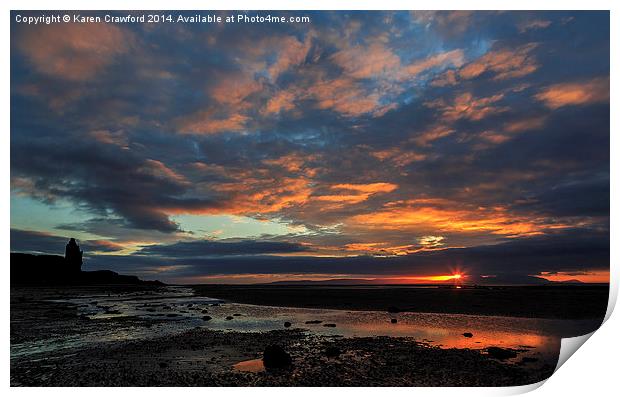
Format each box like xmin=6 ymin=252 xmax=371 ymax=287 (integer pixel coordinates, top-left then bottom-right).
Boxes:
xmin=81 ymin=230 xmax=609 ymax=282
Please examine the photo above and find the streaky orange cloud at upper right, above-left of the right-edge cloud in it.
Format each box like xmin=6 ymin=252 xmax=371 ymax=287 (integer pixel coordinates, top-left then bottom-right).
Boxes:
xmin=459 ymin=43 xmax=538 ymax=80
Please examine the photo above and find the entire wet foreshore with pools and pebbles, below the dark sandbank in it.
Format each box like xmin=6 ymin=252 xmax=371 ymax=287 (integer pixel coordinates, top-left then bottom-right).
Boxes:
xmin=11 ymin=287 xmax=594 ymax=386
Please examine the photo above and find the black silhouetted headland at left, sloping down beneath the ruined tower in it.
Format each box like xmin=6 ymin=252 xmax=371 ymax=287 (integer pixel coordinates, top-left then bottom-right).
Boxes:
xmin=11 ymin=252 xmax=164 ymax=286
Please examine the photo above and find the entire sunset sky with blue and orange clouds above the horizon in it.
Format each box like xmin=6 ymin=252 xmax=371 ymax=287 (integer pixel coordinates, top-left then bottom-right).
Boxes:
xmin=10 ymin=11 xmax=610 ymax=283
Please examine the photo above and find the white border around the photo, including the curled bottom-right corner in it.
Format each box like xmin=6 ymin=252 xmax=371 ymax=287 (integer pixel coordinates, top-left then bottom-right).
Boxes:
xmin=0 ymin=0 xmax=620 ymax=397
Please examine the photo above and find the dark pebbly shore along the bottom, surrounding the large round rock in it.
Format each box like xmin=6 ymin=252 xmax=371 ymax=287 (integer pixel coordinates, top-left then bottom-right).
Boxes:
xmin=11 ymin=329 xmax=553 ymax=386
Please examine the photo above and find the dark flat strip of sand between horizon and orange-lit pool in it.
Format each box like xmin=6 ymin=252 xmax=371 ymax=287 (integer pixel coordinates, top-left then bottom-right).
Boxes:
xmin=192 ymin=284 xmax=609 ymax=320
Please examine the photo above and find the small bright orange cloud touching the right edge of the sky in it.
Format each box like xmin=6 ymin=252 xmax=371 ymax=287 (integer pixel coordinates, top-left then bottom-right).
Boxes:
xmin=534 ymin=76 xmax=609 ymax=110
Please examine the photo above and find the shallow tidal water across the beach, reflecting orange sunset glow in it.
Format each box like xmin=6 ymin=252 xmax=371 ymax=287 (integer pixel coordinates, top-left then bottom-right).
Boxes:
xmin=11 ymin=287 xmax=593 ymax=370
